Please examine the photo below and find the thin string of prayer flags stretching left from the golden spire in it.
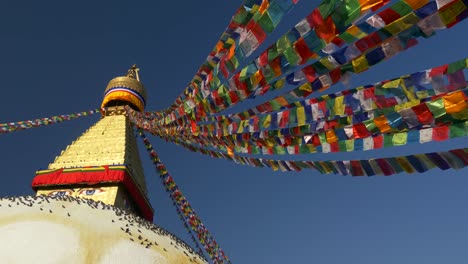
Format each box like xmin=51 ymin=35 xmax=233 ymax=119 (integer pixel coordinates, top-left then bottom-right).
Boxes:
xmin=0 ymin=109 xmax=99 ymax=133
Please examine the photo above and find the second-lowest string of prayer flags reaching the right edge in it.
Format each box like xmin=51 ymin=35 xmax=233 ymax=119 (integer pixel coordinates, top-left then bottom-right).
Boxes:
xmin=144 ymin=118 xmax=468 ymax=158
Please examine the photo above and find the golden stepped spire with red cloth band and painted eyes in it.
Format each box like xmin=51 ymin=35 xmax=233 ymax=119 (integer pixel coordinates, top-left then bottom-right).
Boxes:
xmin=33 ymin=65 xmax=153 ymax=220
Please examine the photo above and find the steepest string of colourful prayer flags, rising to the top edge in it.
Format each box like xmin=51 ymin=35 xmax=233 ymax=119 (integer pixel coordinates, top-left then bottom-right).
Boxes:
xmin=162 ymin=0 xmax=299 ymax=120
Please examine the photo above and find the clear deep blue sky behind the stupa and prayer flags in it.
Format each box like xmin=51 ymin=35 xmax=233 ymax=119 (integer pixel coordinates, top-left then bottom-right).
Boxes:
xmin=0 ymin=0 xmax=468 ymax=264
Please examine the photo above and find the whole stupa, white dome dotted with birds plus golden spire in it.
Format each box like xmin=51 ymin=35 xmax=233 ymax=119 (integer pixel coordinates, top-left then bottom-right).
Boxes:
xmin=0 ymin=65 xmax=207 ymax=263
